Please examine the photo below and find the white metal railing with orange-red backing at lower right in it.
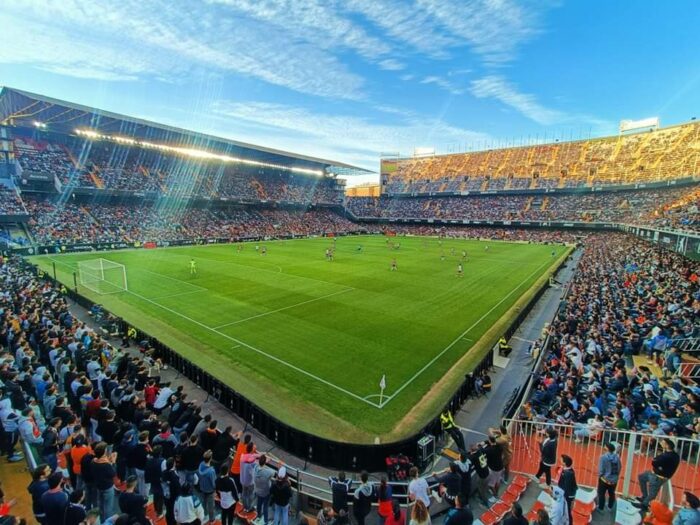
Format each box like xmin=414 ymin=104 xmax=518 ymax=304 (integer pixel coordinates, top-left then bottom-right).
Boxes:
xmin=506 ymin=419 xmax=700 ymax=504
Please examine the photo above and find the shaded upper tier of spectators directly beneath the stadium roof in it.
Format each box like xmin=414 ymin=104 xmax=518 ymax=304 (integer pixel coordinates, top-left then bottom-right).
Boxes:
xmin=14 ymin=136 xmax=343 ymax=205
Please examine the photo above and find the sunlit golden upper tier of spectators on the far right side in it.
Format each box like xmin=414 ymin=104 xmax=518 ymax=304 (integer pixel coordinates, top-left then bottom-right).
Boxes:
xmin=386 ymin=122 xmax=700 ymax=193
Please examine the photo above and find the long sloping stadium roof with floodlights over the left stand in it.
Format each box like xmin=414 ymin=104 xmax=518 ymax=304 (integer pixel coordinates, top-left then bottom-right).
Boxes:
xmin=0 ymin=87 xmax=372 ymax=175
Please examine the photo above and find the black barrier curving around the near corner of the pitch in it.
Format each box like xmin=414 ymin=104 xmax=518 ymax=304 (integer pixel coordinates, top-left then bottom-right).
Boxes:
xmin=20 ymin=248 xmax=566 ymax=471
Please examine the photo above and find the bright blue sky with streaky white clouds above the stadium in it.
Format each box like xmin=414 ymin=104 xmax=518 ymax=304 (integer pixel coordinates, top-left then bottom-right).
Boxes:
xmin=0 ymin=0 xmax=700 ymax=185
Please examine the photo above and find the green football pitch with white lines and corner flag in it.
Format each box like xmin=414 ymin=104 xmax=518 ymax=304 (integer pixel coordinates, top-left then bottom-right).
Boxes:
xmin=31 ymin=236 xmax=569 ymax=443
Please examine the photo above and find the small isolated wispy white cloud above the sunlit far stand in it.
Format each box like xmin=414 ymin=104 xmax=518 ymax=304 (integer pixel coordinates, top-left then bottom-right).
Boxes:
xmin=470 ymin=75 xmax=566 ymax=125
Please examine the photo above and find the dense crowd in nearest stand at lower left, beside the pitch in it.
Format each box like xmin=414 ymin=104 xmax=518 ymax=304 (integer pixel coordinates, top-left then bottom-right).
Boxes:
xmin=0 ymin=255 xmax=314 ymax=525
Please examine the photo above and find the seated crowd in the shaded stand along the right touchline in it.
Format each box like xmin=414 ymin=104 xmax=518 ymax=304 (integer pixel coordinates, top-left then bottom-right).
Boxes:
xmin=521 ymin=234 xmax=700 ymax=453
